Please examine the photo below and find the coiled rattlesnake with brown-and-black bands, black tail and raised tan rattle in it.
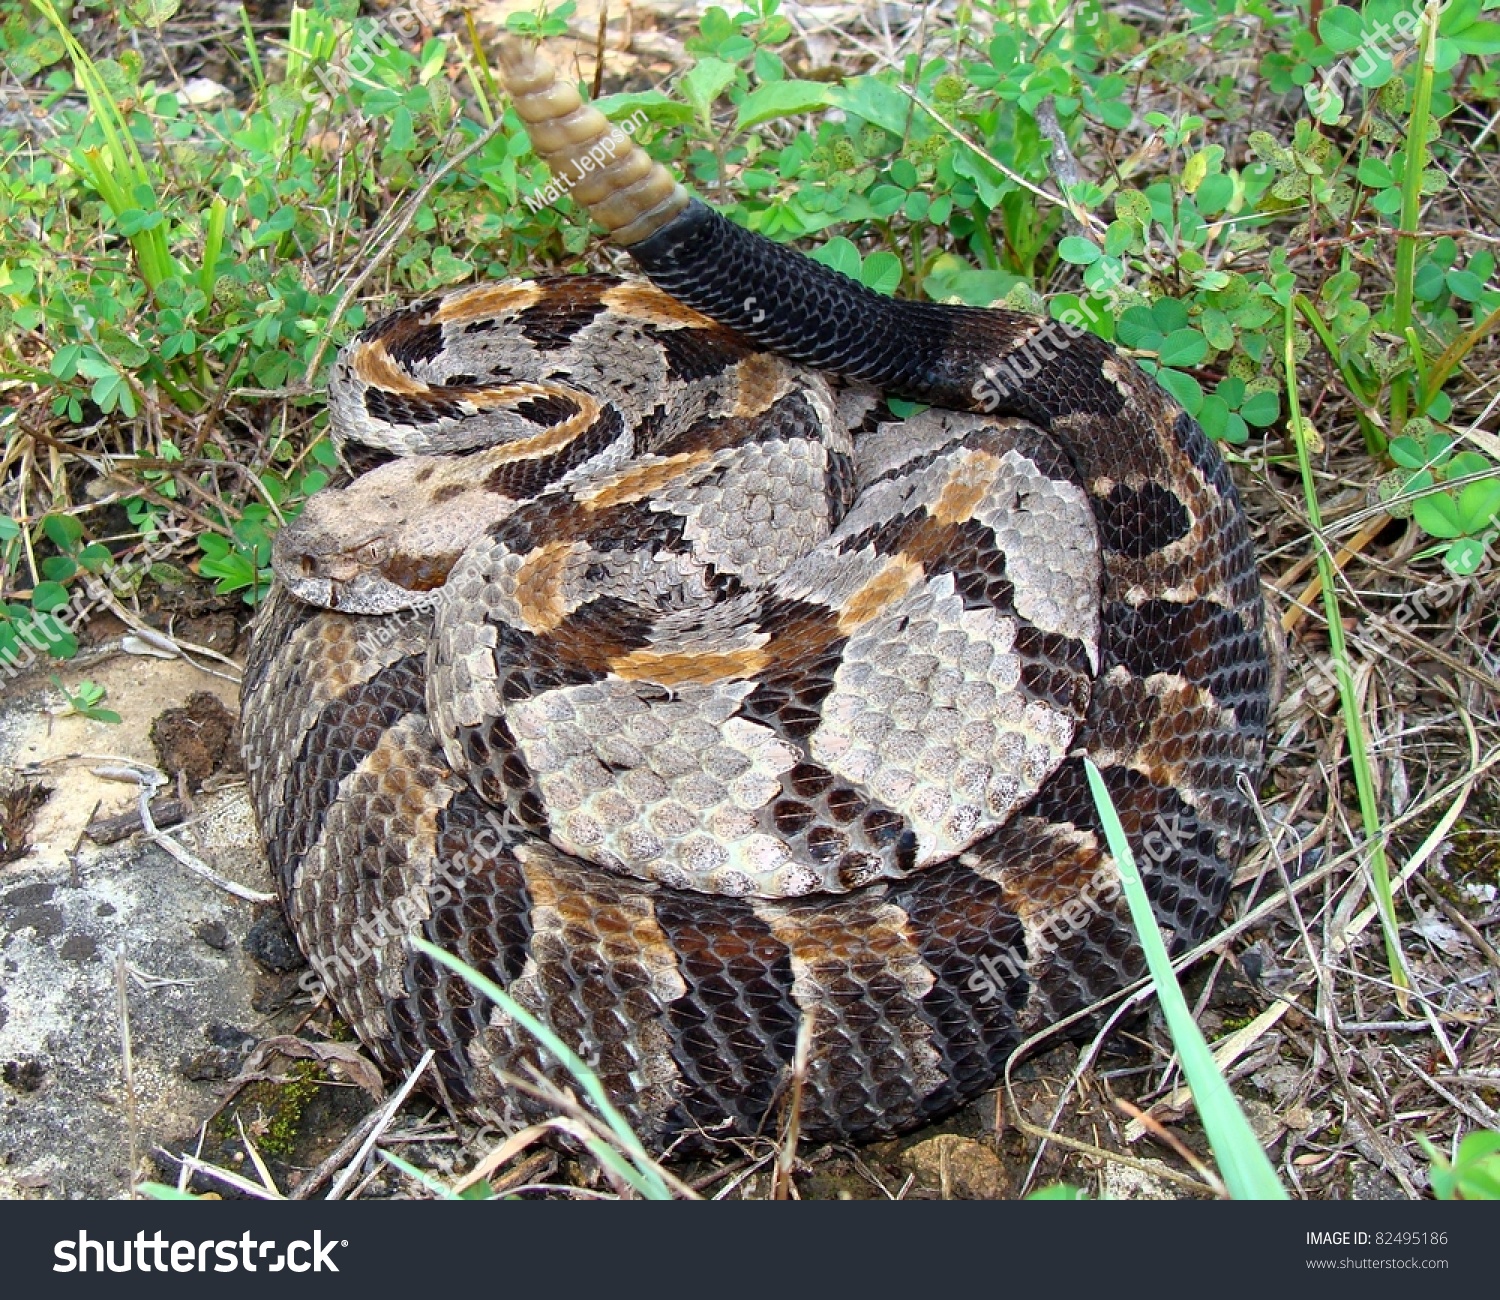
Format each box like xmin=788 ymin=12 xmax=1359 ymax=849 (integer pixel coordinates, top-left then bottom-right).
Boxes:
xmin=245 ymin=45 xmax=1268 ymax=1147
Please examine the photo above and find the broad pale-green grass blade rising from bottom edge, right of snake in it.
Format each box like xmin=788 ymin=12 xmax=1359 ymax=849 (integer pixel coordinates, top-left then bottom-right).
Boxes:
xmin=1085 ymin=760 xmax=1287 ymax=1201
